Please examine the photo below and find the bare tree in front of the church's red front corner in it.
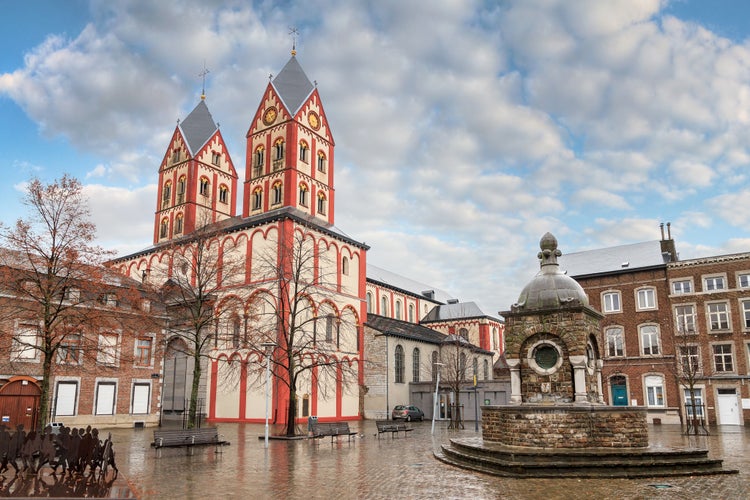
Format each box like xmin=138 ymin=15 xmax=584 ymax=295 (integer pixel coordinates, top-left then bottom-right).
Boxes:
xmin=248 ymin=230 xmax=357 ymax=436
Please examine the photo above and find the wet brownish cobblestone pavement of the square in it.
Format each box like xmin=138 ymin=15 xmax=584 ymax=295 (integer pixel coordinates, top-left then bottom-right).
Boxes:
xmin=107 ymin=421 xmax=750 ymax=500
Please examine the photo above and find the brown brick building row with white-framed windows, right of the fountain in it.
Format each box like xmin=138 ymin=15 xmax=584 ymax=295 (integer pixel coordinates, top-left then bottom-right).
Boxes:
xmin=560 ymin=228 xmax=750 ymax=425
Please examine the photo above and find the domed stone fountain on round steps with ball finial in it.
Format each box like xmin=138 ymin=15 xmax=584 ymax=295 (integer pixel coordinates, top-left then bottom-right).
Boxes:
xmin=435 ymin=233 xmax=737 ymax=477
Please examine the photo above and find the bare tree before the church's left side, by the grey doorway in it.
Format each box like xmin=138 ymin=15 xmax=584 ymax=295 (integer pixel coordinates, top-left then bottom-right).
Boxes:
xmin=155 ymin=220 xmax=244 ymax=428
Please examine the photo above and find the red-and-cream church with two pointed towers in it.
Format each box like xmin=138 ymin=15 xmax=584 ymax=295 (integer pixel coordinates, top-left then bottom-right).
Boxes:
xmin=110 ymin=50 xmax=503 ymax=424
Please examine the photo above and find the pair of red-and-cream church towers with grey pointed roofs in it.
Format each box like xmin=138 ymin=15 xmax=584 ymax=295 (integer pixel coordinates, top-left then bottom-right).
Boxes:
xmin=153 ymin=56 xmax=335 ymax=245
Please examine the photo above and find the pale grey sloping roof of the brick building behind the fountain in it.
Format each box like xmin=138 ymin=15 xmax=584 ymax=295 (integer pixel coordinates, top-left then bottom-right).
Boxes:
xmin=558 ymin=240 xmax=669 ymax=277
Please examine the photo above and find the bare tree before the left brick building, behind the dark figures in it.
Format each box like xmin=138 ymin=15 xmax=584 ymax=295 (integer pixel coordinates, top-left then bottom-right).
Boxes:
xmin=0 ymin=175 xmax=140 ymax=428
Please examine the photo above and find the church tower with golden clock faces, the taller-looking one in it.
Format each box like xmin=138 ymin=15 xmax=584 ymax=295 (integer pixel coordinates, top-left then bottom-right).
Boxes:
xmin=242 ymin=51 xmax=334 ymax=225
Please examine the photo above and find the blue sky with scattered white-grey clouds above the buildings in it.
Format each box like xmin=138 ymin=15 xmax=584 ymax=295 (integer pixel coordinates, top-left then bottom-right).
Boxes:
xmin=0 ymin=0 xmax=750 ymax=316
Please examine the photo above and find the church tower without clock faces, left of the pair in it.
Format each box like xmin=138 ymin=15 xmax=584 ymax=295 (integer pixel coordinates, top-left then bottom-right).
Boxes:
xmin=154 ymin=95 xmax=237 ymax=244
